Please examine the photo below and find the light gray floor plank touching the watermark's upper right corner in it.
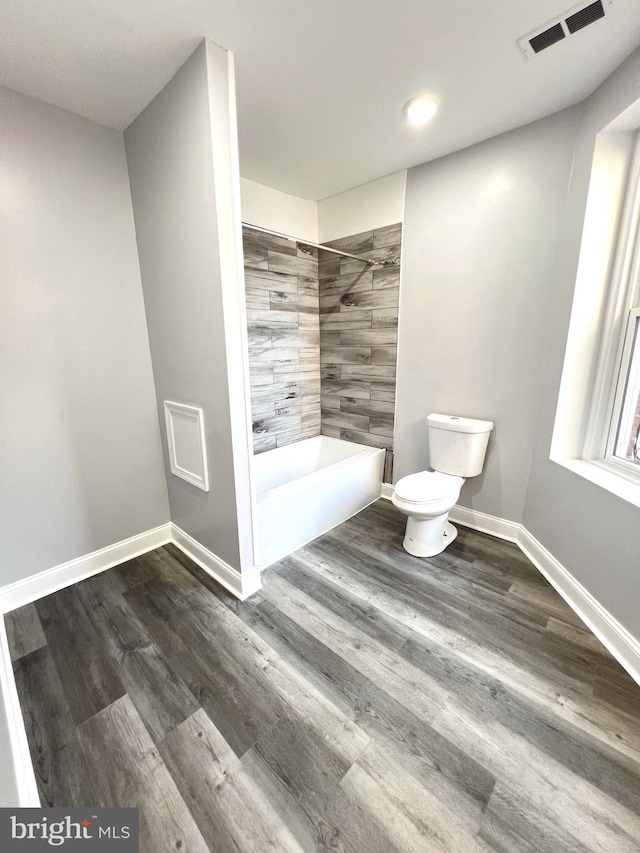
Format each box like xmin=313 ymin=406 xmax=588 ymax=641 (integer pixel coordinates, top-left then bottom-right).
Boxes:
xmin=78 ymin=696 xmax=208 ymax=853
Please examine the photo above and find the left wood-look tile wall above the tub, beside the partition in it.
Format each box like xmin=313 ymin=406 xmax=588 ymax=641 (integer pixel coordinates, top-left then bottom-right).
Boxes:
xmin=243 ymin=228 xmax=320 ymax=453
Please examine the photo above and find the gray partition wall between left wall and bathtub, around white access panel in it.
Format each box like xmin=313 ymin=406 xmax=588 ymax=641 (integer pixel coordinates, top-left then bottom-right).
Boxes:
xmin=125 ymin=42 xmax=253 ymax=569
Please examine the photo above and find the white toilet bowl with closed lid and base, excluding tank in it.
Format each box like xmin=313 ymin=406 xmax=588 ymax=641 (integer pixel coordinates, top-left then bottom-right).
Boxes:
xmin=391 ymin=471 xmax=465 ymax=557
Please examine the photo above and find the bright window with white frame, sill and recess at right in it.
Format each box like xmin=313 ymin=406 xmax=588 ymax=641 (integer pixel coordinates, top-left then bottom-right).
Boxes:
xmin=550 ymin=118 xmax=640 ymax=507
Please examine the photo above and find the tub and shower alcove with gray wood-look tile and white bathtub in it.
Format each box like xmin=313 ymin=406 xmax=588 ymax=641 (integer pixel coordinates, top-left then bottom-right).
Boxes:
xmin=243 ymin=224 xmax=402 ymax=568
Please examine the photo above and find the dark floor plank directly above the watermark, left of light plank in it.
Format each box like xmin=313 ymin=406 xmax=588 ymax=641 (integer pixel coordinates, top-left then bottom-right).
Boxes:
xmin=14 ymin=646 xmax=97 ymax=808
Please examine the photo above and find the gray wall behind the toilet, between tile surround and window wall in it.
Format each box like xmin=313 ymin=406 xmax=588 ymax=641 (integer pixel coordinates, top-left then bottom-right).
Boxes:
xmin=394 ymin=108 xmax=580 ymax=522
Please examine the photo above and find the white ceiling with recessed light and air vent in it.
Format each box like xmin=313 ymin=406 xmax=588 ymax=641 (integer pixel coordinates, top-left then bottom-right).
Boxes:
xmin=0 ymin=0 xmax=640 ymax=199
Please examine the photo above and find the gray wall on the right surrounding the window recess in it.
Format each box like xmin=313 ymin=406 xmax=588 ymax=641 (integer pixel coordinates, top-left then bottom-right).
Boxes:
xmin=523 ymin=50 xmax=640 ymax=637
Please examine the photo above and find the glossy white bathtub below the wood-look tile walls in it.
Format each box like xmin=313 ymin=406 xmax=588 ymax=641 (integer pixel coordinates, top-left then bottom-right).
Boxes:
xmin=253 ymin=435 xmax=385 ymax=568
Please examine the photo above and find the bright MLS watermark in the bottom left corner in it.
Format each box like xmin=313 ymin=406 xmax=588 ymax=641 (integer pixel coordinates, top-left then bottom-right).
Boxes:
xmin=0 ymin=808 xmax=139 ymax=853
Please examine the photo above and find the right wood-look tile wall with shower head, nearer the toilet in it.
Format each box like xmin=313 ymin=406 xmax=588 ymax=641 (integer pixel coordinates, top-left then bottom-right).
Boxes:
xmin=319 ymin=223 xmax=402 ymax=482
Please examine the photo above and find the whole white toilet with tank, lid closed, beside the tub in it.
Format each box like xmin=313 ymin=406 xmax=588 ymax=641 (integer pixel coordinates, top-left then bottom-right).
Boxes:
xmin=391 ymin=414 xmax=493 ymax=557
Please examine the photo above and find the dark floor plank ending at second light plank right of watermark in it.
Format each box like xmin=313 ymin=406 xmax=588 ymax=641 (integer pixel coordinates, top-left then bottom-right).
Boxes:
xmin=78 ymin=572 xmax=200 ymax=742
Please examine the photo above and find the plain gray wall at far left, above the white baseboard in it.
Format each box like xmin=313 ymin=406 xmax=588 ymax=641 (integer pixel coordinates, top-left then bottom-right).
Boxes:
xmin=0 ymin=88 xmax=169 ymax=585
